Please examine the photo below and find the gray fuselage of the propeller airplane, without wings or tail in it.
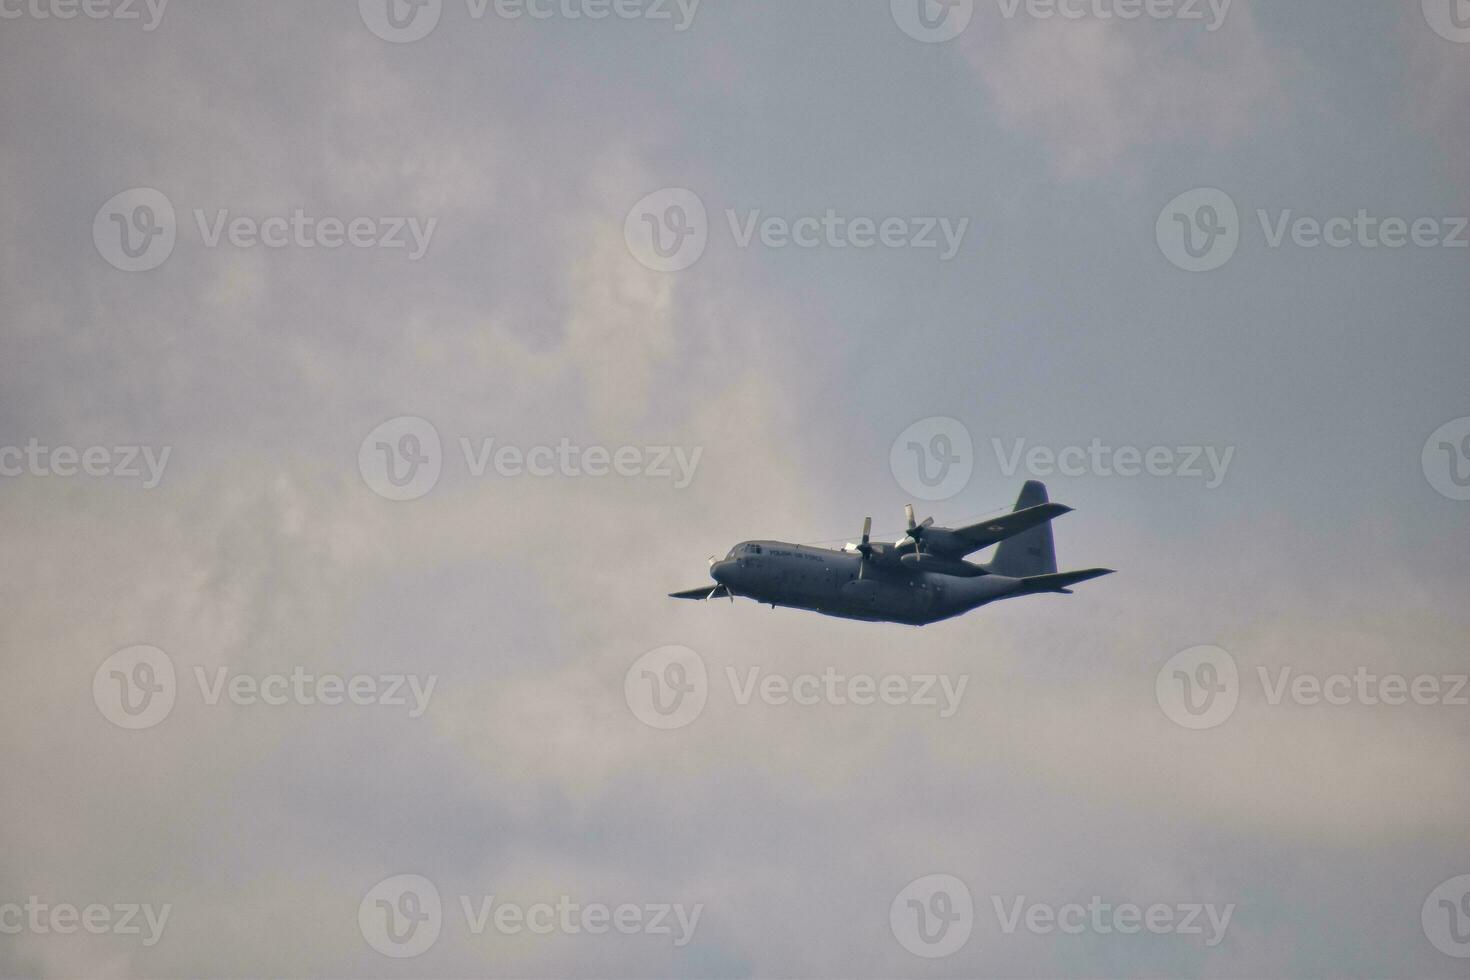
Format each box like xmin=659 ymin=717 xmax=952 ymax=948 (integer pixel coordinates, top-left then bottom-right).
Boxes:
xmin=710 ymin=541 xmax=1026 ymax=626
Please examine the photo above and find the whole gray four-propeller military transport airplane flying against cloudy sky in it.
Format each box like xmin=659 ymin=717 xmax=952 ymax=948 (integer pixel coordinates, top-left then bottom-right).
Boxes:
xmin=669 ymin=480 xmax=1113 ymax=626
